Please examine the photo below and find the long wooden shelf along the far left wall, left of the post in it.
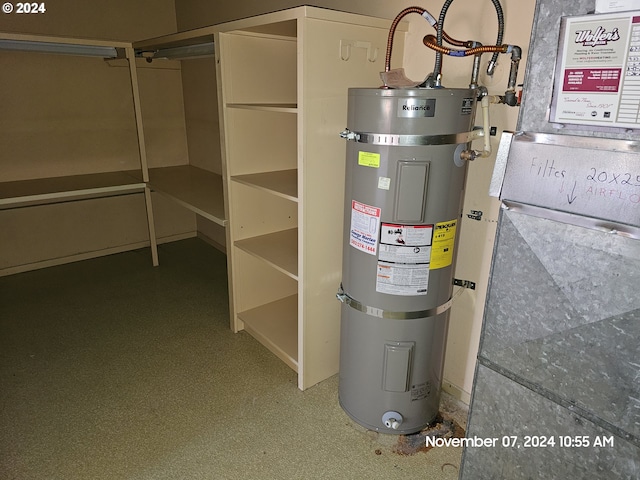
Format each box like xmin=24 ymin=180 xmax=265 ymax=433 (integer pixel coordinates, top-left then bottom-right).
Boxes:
xmin=0 ymin=171 xmax=145 ymax=209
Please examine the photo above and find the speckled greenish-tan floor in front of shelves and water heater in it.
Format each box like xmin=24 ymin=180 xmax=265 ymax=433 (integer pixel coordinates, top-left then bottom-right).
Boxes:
xmin=0 ymin=239 xmax=466 ymax=480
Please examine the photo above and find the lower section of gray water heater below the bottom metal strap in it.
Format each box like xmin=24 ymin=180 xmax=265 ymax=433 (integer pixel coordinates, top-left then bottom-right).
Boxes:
xmin=339 ymin=304 xmax=448 ymax=435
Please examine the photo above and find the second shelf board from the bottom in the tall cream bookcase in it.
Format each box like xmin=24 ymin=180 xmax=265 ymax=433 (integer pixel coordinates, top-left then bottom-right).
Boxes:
xmin=234 ymin=228 xmax=298 ymax=280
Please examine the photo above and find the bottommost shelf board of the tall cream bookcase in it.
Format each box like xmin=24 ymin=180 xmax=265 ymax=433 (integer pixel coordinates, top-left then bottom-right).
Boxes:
xmin=238 ymin=295 xmax=298 ymax=372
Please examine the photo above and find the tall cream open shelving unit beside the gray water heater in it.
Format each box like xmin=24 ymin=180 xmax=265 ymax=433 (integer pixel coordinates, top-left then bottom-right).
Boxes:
xmin=215 ymin=7 xmax=406 ymax=389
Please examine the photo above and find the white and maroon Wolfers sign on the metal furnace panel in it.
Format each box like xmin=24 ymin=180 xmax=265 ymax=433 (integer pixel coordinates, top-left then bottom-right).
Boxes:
xmin=550 ymin=11 xmax=640 ymax=128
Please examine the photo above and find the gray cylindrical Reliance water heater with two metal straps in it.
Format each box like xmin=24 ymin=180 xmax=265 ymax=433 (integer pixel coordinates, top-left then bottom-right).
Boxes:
xmin=338 ymin=88 xmax=478 ymax=434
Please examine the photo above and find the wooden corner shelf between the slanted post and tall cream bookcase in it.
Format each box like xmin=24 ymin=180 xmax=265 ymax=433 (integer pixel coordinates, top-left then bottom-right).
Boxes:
xmin=149 ymin=165 xmax=227 ymax=227
